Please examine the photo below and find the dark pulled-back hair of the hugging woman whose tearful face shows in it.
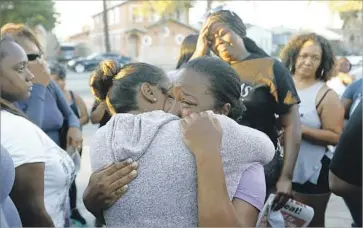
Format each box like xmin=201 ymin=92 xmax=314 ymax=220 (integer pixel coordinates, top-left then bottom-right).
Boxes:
xmin=182 ymin=56 xmax=246 ymax=123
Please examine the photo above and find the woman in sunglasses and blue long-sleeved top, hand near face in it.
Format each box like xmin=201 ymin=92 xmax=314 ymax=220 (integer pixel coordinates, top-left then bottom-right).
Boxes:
xmin=1 ymin=24 xmax=82 ymax=152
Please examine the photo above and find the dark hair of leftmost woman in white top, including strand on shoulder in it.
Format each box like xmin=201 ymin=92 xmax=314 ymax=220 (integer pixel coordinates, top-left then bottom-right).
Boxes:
xmin=0 ymin=36 xmax=27 ymax=118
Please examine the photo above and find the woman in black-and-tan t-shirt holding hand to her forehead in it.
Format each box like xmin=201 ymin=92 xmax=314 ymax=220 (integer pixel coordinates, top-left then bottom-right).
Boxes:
xmin=192 ymin=10 xmax=301 ymax=210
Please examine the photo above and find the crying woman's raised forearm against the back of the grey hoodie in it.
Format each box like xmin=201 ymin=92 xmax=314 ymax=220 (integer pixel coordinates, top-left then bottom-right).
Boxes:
xmin=196 ymin=151 xmax=240 ymax=227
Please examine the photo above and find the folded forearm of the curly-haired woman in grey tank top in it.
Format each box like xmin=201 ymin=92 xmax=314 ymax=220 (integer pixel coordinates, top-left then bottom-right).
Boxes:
xmin=302 ymin=126 xmax=340 ymax=146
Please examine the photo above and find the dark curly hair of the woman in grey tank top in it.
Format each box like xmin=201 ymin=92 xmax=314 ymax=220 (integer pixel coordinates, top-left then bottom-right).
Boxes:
xmin=280 ymin=33 xmax=335 ymax=82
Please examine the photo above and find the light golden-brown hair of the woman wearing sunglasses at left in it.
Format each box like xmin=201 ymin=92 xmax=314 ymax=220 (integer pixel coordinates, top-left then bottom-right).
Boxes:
xmin=0 ymin=23 xmax=43 ymax=53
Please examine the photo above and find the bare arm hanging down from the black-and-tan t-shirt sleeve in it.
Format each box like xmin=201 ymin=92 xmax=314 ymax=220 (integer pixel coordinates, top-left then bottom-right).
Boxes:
xmin=272 ymin=105 xmax=301 ymax=211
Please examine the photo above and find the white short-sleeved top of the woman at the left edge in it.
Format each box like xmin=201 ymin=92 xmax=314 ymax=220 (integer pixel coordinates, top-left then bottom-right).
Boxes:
xmin=0 ymin=111 xmax=75 ymax=227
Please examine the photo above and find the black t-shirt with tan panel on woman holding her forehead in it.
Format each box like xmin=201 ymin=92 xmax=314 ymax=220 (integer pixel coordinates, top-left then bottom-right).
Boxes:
xmin=232 ymin=54 xmax=300 ymax=146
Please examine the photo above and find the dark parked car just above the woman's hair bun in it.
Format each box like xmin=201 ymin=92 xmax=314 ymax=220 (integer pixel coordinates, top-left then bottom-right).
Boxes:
xmin=68 ymin=53 xmax=131 ymax=73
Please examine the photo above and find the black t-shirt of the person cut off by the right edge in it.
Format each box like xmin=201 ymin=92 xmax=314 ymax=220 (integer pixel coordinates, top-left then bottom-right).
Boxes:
xmin=330 ymin=101 xmax=362 ymax=187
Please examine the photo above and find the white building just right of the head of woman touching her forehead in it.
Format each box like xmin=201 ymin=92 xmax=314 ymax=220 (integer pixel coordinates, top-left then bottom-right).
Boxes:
xmin=246 ymin=24 xmax=273 ymax=55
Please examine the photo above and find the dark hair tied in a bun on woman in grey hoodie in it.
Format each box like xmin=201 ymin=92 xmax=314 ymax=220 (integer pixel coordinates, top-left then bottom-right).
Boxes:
xmin=90 ymin=60 xmax=167 ymax=115
